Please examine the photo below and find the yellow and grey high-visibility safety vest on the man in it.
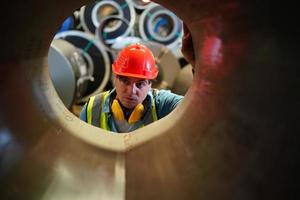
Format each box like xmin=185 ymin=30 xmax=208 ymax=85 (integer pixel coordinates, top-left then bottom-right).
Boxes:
xmin=87 ymin=91 xmax=158 ymax=131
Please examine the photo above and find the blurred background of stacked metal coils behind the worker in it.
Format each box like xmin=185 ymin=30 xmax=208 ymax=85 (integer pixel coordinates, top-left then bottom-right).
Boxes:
xmin=48 ymin=0 xmax=193 ymax=116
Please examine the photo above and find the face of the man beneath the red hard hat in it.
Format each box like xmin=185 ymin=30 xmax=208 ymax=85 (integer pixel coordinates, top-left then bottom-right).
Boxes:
xmin=114 ymin=75 xmax=151 ymax=109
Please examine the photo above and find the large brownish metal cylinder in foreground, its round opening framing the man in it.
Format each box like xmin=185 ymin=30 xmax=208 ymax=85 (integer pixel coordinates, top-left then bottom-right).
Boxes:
xmin=0 ymin=0 xmax=299 ymax=200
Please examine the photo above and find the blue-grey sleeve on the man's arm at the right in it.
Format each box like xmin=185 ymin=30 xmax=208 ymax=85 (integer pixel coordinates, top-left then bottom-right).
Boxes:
xmin=155 ymin=90 xmax=183 ymax=119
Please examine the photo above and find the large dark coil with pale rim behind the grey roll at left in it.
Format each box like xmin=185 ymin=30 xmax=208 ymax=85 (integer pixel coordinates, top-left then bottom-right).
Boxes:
xmin=55 ymin=31 xmax=111 ymax=101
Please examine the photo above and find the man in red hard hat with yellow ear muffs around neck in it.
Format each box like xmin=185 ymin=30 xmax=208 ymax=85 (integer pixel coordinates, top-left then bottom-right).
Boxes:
xmin=80 ymin=44 xmax=183 ymax=133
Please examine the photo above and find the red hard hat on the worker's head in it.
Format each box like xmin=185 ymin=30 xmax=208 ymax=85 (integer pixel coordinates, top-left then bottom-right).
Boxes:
xmin=112 ymin=44 xmax=158 ymax=79
